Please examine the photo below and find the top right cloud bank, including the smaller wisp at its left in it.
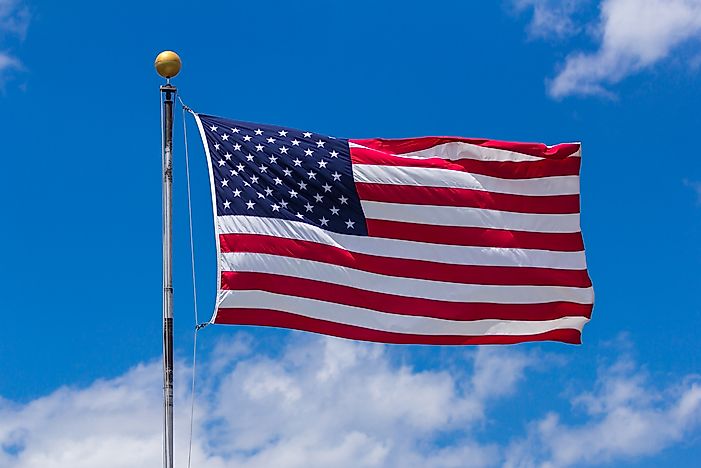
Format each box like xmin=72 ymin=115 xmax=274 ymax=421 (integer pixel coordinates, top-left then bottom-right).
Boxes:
xmin=515 ymin=0 xmax=701 ymax=98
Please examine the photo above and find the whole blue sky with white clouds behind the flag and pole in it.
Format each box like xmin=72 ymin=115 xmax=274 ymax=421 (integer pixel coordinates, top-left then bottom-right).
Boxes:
xmin=0 ymin=0 xmax=701 ymax=468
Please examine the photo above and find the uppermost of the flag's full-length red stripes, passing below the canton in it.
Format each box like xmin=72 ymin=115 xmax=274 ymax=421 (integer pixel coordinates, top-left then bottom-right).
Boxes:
xmin=219 ymin=234 xmax=591 ymax=288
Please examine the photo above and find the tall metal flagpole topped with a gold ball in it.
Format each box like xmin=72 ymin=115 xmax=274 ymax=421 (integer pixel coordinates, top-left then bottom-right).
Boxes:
xmin=155 ymin=51 xmax=181 ymax=468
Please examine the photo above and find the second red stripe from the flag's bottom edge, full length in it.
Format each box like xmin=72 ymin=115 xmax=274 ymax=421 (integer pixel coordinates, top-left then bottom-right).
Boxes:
xmin=221 ymin=271 xmax=593 ymax=320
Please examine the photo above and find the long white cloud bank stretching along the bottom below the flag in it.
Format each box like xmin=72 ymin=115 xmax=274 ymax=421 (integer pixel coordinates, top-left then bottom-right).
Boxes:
xmin=0 ymin=335 xmax=701 ymax=468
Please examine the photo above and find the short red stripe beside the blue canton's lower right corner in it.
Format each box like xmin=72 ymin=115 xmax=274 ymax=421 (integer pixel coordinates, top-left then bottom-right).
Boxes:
xmin=366 ymin=219 xmax=584 ymax=252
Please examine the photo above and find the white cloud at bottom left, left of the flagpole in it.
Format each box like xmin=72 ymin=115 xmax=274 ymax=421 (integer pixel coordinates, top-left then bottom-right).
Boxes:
xmin=0 ymin=364 xmax=161 ymax=468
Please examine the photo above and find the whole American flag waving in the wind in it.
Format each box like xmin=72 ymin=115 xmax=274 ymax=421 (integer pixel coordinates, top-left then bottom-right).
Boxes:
xmin=195 ymin=114 xmax=593 ymax=345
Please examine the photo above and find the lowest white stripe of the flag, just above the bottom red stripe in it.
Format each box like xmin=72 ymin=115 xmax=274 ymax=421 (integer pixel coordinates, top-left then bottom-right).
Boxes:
xmin=219 ymin=291 xmax=588 ymax=336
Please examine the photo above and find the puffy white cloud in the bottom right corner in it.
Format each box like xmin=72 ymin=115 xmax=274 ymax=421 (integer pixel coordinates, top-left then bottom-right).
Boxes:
xmin=506 ymin=352 xmax=701 ymax=468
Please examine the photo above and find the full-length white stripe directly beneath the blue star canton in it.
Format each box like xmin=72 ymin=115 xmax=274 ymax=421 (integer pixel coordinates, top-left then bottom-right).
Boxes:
xmin=216 ymin=215 xmax=587 ymax=270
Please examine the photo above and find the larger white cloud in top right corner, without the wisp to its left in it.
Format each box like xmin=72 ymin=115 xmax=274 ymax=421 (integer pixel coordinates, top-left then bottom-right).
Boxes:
xmin=548 ymin=0 xmax=701 ymax=98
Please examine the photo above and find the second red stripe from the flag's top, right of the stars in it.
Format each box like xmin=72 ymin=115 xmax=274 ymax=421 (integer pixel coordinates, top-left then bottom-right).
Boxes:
xmin=350 ymin=147 xmax=582 ymax=179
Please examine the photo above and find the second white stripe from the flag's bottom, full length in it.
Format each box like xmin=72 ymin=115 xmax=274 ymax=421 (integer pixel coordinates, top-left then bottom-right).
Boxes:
xmin=221 ymin=252 xmax=594 ymax=304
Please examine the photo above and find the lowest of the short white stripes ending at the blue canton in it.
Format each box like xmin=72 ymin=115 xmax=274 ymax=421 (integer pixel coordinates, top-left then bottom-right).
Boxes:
xmin=361 ymin=200 xmax=580 ymax=233
